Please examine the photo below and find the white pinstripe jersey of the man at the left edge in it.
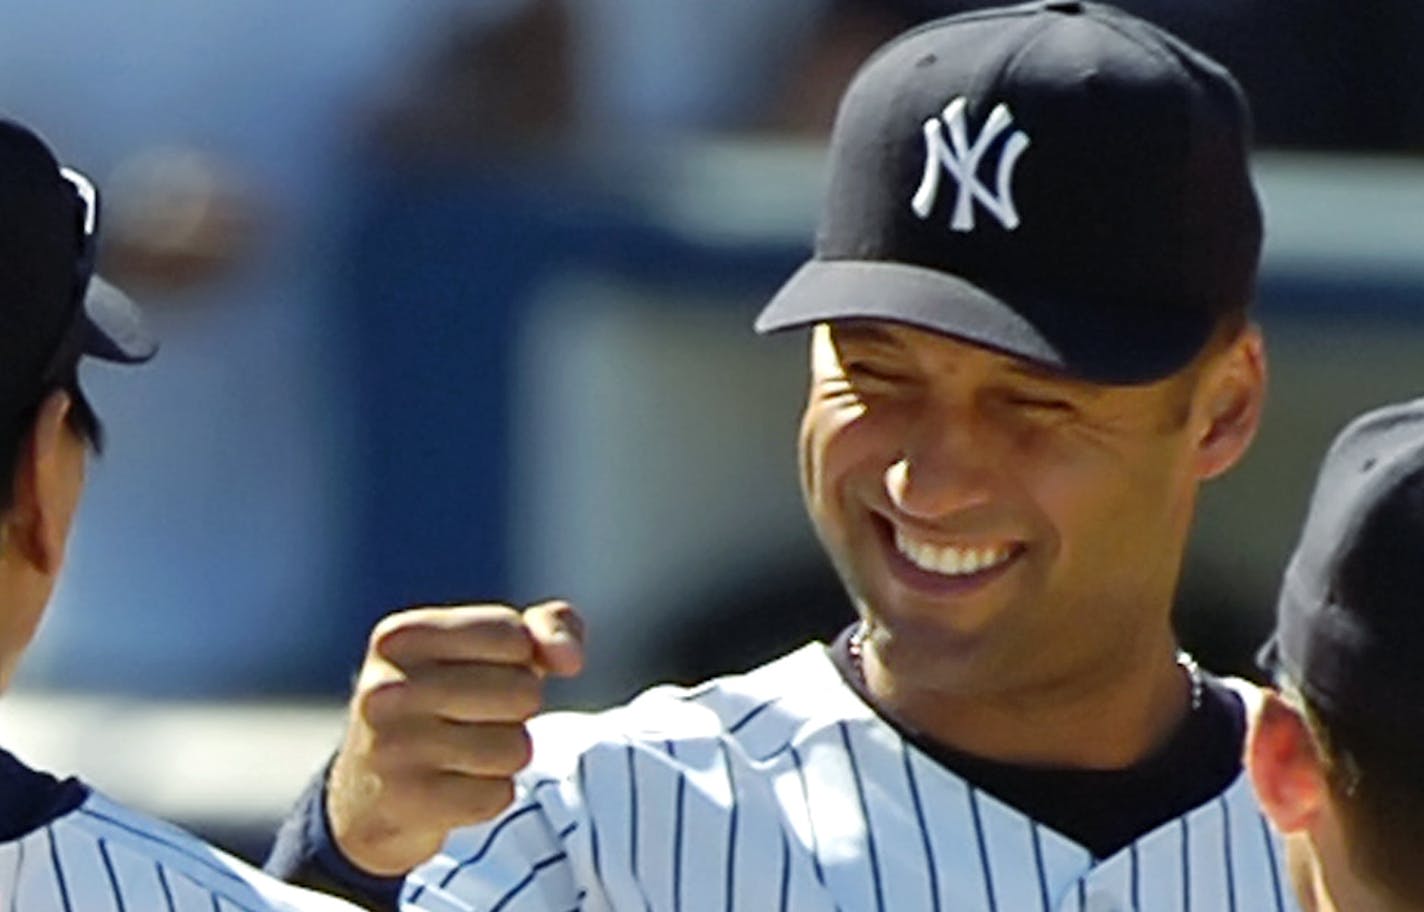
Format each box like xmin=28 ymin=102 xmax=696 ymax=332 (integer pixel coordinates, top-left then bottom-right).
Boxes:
xmin=0 ymin=794 xmax=356 ymax=912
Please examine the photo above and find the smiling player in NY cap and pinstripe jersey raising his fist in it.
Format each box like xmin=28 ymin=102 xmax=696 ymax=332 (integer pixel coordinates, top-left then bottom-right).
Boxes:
xmin=264 ymin=0 xmax=1292 ymax=912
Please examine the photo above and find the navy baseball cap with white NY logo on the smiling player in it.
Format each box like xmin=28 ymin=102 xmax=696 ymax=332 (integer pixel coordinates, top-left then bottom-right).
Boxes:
xmin=756 ymin=0 xmax=1262 ymax=383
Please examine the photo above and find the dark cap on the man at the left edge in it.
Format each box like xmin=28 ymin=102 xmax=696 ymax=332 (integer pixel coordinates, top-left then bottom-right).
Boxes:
xmin=0 ymin=120 xmax=157 ymax=423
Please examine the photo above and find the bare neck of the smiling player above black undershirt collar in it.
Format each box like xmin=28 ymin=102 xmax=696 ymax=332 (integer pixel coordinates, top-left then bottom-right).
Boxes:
xmin=860 ymin=633 xmax=1200 ymax=770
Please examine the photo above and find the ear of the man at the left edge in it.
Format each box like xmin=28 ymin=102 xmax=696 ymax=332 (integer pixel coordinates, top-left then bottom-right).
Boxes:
xmin=4 ymin=390 xmax=77 ymax=576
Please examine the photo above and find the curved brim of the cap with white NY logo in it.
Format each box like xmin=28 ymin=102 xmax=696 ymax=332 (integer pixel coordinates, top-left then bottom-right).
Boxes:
xmin=756 ymin=259 xmax=1210 ymax=385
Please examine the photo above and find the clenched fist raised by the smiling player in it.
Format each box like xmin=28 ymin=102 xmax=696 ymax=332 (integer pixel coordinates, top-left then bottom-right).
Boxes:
xmin=326 ymin=601 xmax=584 ymax=876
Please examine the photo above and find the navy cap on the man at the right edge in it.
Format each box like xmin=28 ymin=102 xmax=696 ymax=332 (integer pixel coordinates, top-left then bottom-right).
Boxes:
xmin=1257 ymin=399 xmax=1424 ymax=741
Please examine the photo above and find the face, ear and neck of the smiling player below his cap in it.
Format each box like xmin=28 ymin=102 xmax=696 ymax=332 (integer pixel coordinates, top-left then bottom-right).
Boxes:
xmin=800 ymin=313 xmax=1260 ymax=768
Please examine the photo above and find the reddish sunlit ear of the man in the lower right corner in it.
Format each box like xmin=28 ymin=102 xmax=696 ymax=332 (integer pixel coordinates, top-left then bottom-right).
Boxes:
xmin=1246 ymin=693 xmax=1330 ymax=834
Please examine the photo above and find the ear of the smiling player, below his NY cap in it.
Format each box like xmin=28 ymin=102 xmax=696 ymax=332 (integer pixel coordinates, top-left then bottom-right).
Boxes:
xmin=1196 ymin=326 xmax=1266 ymax=480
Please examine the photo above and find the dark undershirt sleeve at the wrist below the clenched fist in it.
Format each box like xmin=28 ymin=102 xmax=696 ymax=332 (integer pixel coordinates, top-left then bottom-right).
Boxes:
xmin=263 ymin=762 xmax=404 ymax=912
